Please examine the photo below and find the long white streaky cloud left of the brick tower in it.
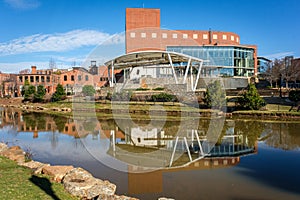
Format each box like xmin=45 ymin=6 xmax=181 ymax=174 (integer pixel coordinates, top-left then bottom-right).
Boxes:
xmin=0 ymin=30 xmax=113 ymax=56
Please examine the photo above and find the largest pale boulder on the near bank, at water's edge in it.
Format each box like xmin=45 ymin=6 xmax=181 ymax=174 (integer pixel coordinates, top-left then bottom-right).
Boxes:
xmin=63 ymin=168 xmax=116 ymax=199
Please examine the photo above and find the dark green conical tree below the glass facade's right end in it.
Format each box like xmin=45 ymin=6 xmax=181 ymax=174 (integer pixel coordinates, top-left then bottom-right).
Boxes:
xmin=237 ymin=84 xmax=266 ymax=110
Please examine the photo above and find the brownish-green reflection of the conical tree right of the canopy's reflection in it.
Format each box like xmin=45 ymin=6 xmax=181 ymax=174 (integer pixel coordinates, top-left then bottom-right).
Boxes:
xmin=234 ymin=120 xmax=264 ymax=146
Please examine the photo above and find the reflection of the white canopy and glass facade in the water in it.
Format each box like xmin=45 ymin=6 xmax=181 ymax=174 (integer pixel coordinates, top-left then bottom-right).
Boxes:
xmin=109 ymin=127 xmax=256 ymax=167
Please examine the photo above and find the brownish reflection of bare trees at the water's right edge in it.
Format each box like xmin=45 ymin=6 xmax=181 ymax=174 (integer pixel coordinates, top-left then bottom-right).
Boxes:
xmin=265 ymin=123 xmax=300 ymax=150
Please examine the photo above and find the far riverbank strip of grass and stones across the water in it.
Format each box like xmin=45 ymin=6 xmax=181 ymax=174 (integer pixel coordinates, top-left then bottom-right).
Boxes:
xmin=0 ymin=97 xmax=300 ymax=120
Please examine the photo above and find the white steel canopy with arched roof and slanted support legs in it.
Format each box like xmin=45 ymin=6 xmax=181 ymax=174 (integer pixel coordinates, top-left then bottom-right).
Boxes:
xmin=105 ymin=51 xmax=203 ymax=91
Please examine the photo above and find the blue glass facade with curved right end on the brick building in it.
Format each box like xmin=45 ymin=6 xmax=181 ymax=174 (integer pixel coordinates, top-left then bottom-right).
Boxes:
xmin=167 ymin=46 xmax=254 ymax=77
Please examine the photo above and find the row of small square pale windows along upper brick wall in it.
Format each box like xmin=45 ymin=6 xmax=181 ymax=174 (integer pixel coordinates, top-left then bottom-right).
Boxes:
xmin=130 ymin=32 xmax=239 ymax=42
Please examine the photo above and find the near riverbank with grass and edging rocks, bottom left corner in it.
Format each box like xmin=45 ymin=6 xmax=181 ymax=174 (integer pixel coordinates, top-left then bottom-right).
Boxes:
xmin=0 ymin=143 xmax=137 ymax=200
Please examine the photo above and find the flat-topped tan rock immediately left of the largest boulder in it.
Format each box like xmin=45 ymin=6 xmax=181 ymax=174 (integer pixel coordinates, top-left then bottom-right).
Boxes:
xmin=42 ymin=166 xmax=74 ymax=183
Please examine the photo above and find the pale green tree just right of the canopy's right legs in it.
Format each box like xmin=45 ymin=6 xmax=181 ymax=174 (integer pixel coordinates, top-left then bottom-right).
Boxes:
xmin=204 ymin=80 xmax=226 ymax=109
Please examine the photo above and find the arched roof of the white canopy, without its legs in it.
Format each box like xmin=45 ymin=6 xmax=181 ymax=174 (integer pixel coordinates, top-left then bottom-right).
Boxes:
xmin=105 ymin=51 xmax=203 ymax=69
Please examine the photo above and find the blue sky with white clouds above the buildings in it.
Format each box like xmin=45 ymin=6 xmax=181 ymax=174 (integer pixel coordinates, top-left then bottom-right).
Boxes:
xmin=0 ymin=0 xmax=300 ymax=73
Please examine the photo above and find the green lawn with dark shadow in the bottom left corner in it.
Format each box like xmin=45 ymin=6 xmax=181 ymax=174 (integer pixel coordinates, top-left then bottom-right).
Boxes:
xmin=0 ymin=156 xmax=78 ymax=200
